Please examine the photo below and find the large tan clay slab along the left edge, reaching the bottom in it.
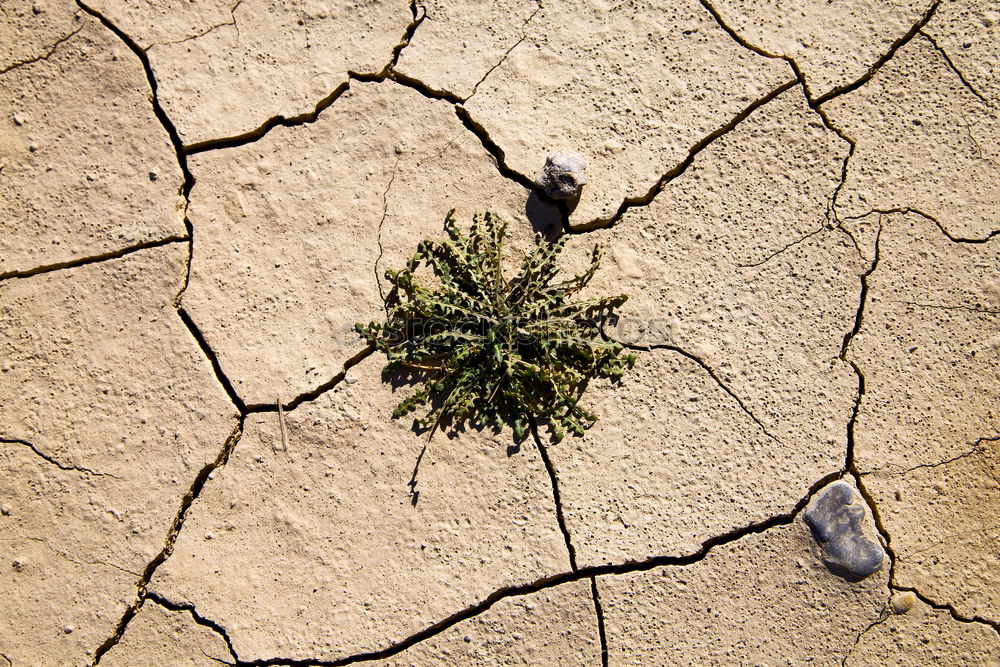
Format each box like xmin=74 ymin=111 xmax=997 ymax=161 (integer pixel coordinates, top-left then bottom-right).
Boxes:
xmin=0 ymin=244 xmax=235 ymax=664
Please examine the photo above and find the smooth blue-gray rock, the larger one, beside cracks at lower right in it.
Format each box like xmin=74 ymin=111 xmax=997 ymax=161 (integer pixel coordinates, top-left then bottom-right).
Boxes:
xmin=805 ymin=481 xmax=885 ymax=581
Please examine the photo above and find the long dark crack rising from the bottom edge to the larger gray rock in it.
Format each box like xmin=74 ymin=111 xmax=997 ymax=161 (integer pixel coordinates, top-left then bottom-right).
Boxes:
xmin=237 ymin=471 xmax=841 ymax=667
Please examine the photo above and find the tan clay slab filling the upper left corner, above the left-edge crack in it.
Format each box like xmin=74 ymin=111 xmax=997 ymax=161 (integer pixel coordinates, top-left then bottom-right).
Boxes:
xmin=0 ymin=13 xmax=186 ymax=277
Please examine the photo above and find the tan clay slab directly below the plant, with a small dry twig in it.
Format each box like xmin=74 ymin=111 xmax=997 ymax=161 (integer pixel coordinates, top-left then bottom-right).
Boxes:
xmin=150 ymin=357 xmax=569 ymax=660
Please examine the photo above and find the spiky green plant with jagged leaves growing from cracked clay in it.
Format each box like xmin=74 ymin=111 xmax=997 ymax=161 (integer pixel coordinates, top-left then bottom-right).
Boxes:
xmin=355 ymin=211 xmax=635 ymax=441
